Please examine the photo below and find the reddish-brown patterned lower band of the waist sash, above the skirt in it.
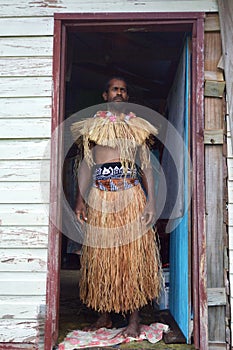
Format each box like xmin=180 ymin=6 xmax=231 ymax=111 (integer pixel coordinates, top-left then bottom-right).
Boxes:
xmin=93 ymin=178 xmax=139 ymax=192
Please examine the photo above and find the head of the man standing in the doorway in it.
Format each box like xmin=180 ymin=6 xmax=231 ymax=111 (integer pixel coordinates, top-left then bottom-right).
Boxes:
xmin=103 ymin=79 xmax=129 ymax=102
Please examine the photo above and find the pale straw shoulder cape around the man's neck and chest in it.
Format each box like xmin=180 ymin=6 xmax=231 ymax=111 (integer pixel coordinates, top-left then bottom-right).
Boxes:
xmin=71 ymin=111 xmax=158 ymax=169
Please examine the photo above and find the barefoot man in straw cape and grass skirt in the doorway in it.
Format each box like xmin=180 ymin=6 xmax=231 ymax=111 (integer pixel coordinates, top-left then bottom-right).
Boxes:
xmin=71 ymin=77 xmax=161 ymax=337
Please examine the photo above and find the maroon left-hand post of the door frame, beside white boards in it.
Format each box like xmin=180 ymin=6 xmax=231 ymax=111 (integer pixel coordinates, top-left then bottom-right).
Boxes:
xmin=44 ymin=17 xmax=65 ymax=350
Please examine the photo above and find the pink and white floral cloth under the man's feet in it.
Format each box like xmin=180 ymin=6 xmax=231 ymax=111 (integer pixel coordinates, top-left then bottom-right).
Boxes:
xmin=58 ymin=323 xmax=169 ymax=350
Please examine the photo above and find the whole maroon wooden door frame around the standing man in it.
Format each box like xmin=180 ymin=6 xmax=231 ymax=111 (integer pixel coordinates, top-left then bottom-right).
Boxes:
xmin=45 ymin=12 xmax=208 ymax=350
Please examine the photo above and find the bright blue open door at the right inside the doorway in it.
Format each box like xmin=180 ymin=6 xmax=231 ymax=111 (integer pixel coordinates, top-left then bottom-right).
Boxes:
xmin=169 ymin=40 xmax=191 ymax=343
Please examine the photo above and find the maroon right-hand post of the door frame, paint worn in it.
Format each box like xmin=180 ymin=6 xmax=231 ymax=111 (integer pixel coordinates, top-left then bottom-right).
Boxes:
xmin=191 ymin=20 xmax=208 ymax=350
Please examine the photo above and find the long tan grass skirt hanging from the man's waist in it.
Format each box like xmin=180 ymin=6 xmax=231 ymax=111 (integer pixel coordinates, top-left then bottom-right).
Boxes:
xmin=80 ymin=185 xmax=161 ymax=313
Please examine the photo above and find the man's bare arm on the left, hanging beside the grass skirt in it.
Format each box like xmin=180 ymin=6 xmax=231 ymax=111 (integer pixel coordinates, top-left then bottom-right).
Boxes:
xmin=75 ymin=160 xmax=92 ymax=224
